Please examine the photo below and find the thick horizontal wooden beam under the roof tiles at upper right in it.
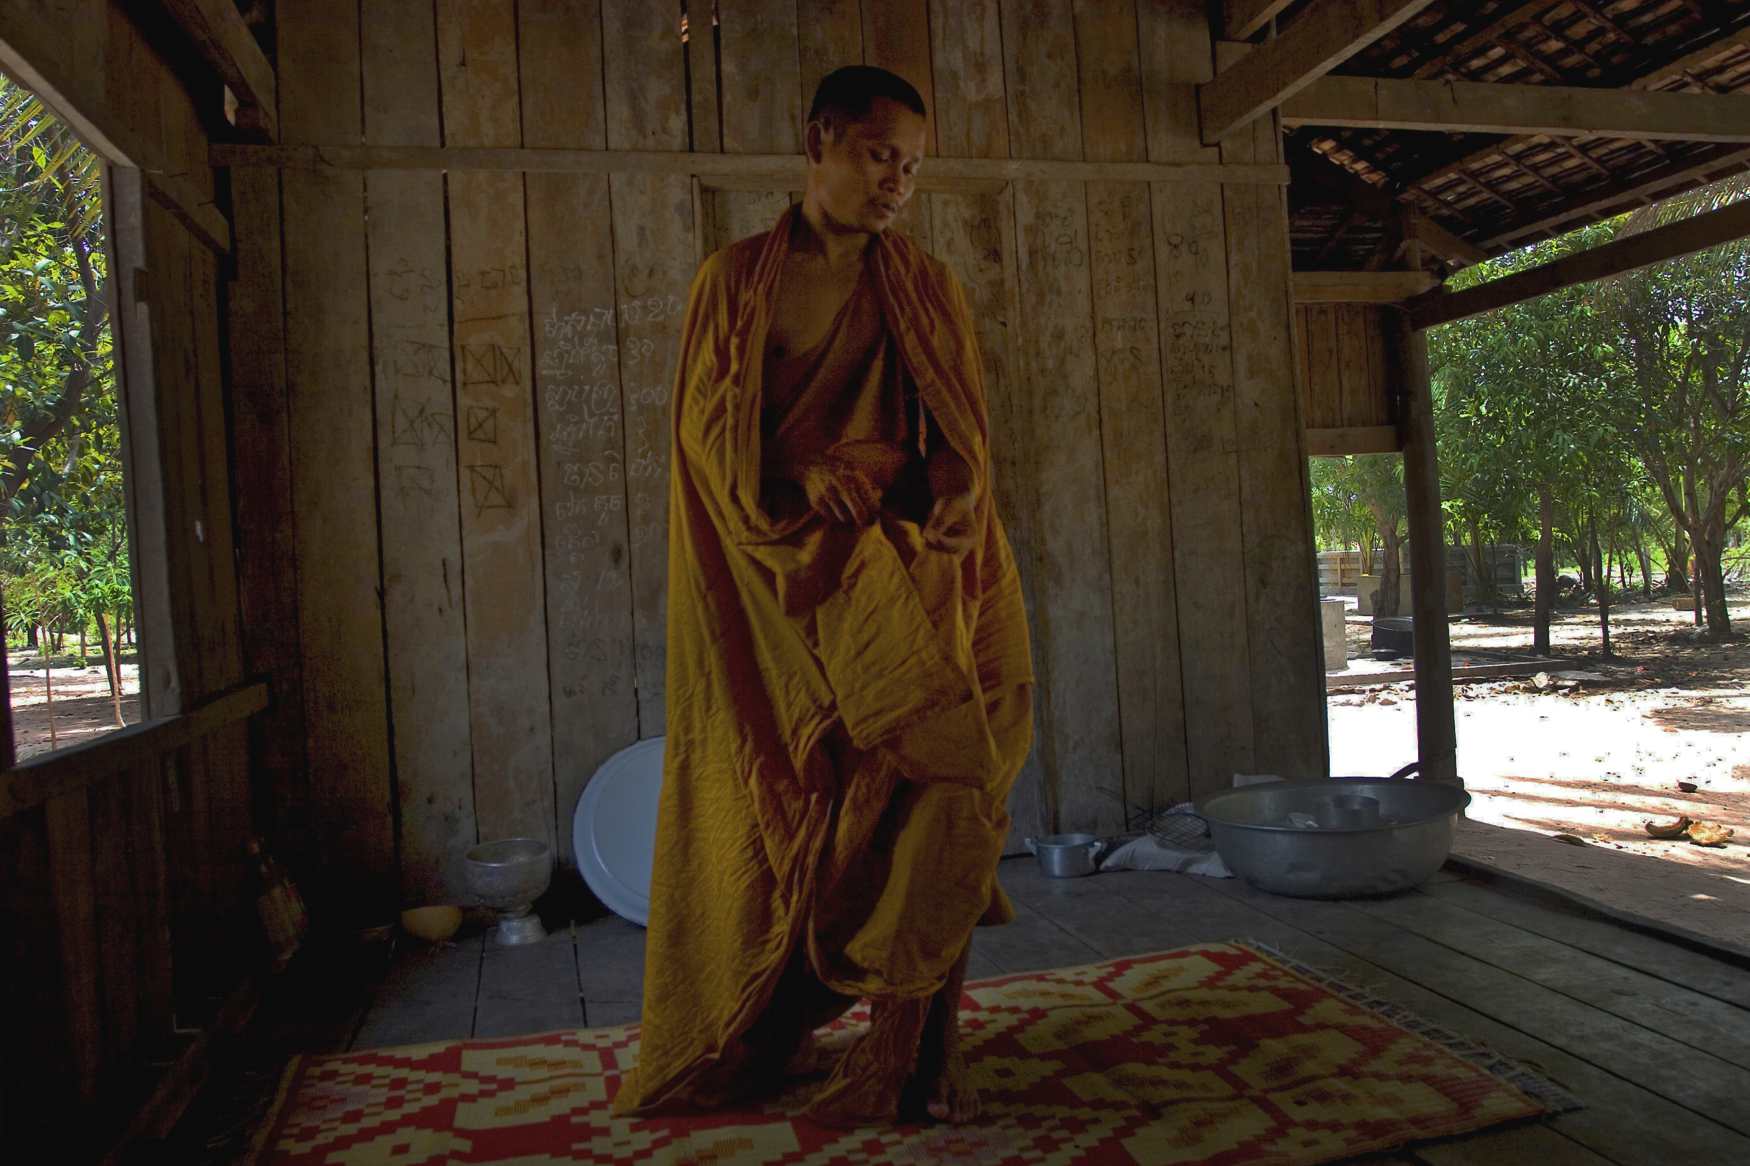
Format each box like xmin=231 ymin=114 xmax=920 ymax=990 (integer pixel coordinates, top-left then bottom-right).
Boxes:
xmin=1283 ymin=77 xmax=1750 ymax=142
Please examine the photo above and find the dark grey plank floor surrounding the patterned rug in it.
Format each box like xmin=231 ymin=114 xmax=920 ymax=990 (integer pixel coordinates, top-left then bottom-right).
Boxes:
xmin=325 ymin=858 xmax=1750 ymax=1166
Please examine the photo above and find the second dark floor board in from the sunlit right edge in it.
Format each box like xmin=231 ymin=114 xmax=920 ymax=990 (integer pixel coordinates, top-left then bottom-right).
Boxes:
xmin=1362 ymin=895 xmax=1750 ymax=1068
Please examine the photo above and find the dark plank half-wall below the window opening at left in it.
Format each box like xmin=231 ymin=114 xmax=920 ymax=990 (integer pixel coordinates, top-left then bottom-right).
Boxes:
xmin=0 ymin=683 xmax=268 ymax=1161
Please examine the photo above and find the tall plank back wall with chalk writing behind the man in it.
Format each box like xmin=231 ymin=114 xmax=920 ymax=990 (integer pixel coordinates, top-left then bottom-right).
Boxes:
xmin=255 ymin=0 xmax=1323 ymax=900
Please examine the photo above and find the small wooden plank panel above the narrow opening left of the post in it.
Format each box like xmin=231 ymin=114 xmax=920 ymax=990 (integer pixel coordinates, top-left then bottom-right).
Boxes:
xmin=1295 ymin=303 xmax=1397 ymax=429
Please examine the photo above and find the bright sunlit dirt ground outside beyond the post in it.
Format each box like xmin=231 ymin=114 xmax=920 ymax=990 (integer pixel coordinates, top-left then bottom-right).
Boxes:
xmin=1328 ymin=594 xmax=1750 ymax=945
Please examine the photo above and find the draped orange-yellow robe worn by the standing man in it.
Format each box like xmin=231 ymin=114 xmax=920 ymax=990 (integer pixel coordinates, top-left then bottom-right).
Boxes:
xmin=614 ymin=210 xmax=1033 ymax=1113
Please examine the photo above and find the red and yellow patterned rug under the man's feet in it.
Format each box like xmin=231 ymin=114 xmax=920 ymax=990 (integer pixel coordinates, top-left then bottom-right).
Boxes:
xmin=257 ymin=944 xmax=1572 ymax=1166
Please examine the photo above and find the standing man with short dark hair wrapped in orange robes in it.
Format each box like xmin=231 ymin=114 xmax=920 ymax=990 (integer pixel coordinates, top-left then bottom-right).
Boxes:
xmin=614 ymin=67 xmax=1033 ymax=1126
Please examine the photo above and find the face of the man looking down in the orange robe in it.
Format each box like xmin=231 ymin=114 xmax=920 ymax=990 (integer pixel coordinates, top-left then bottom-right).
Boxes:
xmin=807 ymin=98 xmax=924 ymax=235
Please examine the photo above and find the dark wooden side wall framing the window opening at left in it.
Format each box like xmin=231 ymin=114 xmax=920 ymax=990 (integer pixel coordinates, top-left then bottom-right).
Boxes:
xmin=0 ymin=0 xmax=260 ymax=1141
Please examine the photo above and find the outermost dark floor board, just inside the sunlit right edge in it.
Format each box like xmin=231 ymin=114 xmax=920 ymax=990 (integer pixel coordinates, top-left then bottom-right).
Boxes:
xmin=1423 ymin=879 xmax=1750 ymax=1008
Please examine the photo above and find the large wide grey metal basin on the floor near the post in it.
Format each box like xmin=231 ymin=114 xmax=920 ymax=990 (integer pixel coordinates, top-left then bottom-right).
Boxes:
xmin=1199 ymin=777 xmax=1470 ymax=898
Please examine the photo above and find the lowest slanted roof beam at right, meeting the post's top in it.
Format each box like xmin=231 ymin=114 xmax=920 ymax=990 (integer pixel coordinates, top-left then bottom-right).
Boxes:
xmin=1407 ymin=198 xmax=1750 ymax=329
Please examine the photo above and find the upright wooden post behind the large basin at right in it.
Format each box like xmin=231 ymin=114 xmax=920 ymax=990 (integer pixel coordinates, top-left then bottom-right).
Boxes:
xmin=1391 ymin=299 xmax=1463 ymax=784
